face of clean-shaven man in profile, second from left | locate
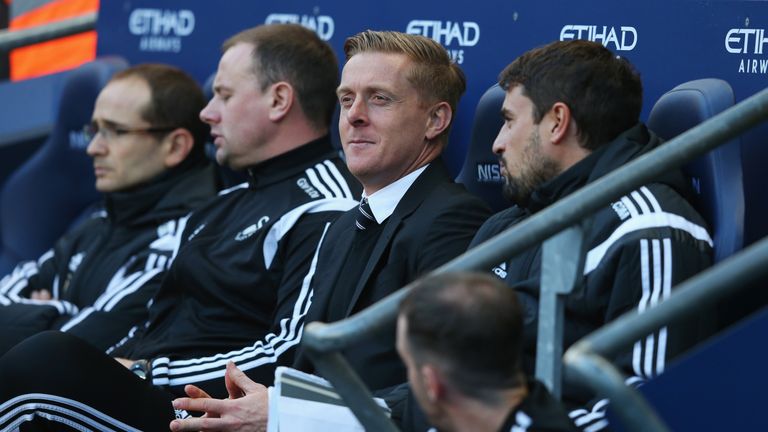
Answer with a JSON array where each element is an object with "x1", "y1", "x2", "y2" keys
[{"x1": 200, "y1": 43, "x2": 272, "y2": 169}]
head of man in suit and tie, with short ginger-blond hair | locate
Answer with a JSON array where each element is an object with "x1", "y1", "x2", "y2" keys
[{"x1": 336, "y1": 31, "x2": 466, "y2": 194}]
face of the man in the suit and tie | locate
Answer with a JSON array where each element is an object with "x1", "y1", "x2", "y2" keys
[{"x1": 337, "y1": 52, "x2": 440, "y2": 194}]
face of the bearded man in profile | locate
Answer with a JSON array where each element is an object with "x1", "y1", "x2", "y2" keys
[{"x1": 493, "y1": 85, "x2": 559, "y2": 205}]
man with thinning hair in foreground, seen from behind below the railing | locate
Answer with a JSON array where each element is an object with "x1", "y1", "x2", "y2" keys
[{"x1": 397, "y1": 273, "x2": 574, "y2": 432}]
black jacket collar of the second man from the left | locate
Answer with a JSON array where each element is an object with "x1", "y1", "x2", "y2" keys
[{"x1": 247, "y1": 135, "x2": 338, "y2": 189}]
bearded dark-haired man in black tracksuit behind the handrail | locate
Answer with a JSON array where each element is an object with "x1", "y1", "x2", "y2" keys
[{"x1": 473, "y1": 40, "x2": 712, "y2": 430}]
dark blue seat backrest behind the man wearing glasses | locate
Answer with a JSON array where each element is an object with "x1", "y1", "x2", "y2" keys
[{"x1": 0, "y1": 57, "x2": 128, "y2": 274}]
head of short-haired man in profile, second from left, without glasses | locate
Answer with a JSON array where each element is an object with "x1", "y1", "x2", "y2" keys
[{"x1": 200, "y1": 24, "x2": 338, "y2": 169}]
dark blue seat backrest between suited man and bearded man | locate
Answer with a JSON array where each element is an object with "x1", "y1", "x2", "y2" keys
[{"x1": 456, "y1": 84, "x2": 509, "y2": 211}]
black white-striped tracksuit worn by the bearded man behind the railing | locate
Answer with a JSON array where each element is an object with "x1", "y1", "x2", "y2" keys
[{"x1": 472, "y1": 124, "x2": 712, "y2": 426}]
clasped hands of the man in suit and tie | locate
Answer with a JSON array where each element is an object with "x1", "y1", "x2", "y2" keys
[{"x1": 170, "y1": 362, "x2": 269, "y2": 432}]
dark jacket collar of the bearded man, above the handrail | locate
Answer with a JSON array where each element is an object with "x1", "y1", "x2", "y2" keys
[{"x1": 525, "y1": 123, "x2": 690, "y2": 213}]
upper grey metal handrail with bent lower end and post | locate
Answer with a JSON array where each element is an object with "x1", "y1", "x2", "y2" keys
[{"x1": 302, "y1": 89, "x2": 768, "y2": 431}]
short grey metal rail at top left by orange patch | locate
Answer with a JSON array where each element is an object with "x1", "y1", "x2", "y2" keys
[{"x1": 0, "y1": 12, "x2": 98, "y2": 52}]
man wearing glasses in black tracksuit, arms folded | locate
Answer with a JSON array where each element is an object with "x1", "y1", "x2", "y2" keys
[{"x1": 0, "y1": 65, "x2": 216, "y2": 354}]
